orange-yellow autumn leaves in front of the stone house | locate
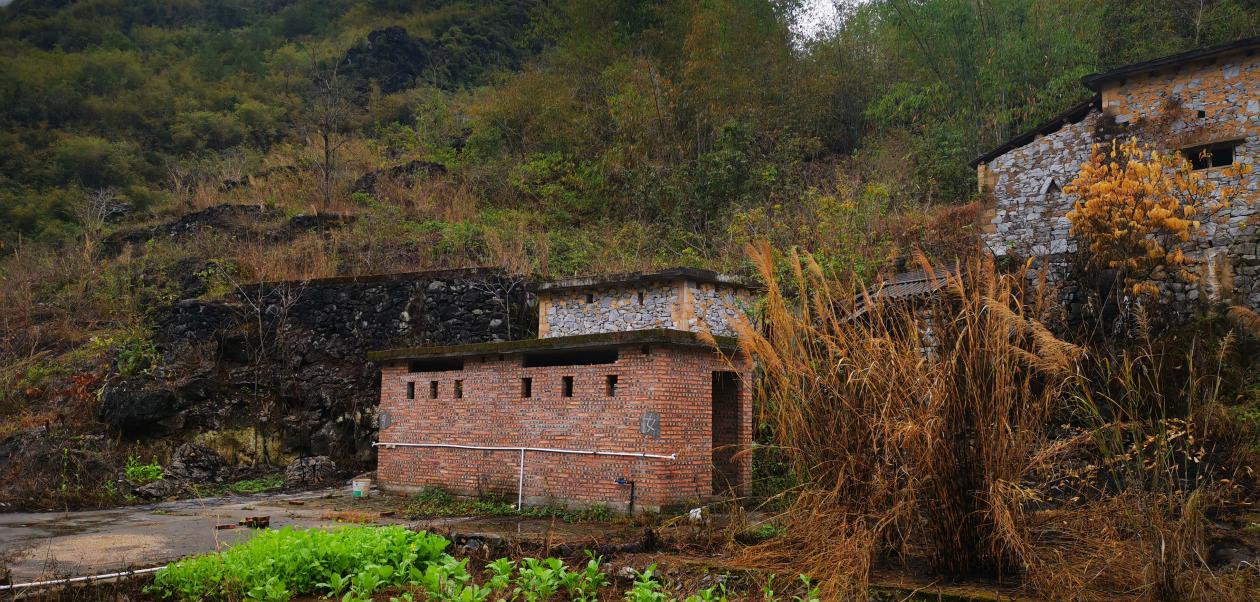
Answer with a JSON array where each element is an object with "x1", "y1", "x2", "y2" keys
[{"x1": 1063, "y1": 139, "x2": 1251, "y2": 298}]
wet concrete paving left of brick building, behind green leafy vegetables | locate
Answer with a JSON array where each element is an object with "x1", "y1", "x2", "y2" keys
[{"x1": 0, "y1": 490, "x2": 367, "y2": 583}]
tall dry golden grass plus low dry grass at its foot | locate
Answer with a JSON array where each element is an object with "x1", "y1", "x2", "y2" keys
[{"x1": 740, "y1": 244, "x2": 1254, "y2": 599}]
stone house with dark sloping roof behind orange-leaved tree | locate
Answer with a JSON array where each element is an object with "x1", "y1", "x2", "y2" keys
[{"x1": 973, "y1": 38, "x2": 1260, "y2": 307}]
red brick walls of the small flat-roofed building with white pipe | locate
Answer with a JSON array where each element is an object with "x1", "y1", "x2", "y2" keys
[{"x1": 377, "y1": 345, "x2": 752, "y2": 509}]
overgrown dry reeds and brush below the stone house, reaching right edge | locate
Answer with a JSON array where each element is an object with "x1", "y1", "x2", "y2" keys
[{"x1": 741, "y1": 241, "x2": 1260, "y2": 599}]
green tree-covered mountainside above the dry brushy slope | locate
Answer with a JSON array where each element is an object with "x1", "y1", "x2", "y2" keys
[{"x1": 0, "y1": 0, "x2": 1260, "y2": 260}]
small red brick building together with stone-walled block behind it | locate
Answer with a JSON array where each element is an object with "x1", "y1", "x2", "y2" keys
[{"x1": 369, "y1": 270, "x2": 752, "y2": 509}]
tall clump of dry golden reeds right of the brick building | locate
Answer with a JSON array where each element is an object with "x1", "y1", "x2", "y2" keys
[{"x1": 740, "y1": 244, "x2": 1081, "y2": 592}]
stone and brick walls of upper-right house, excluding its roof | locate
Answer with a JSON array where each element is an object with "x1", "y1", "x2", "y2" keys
[{"x1": 979, "y1": 48, "x2": 1260, "y2": 310}]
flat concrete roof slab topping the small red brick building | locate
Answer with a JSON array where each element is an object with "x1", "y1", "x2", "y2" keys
[{"x1": 368, "y1": 329, "x2": 738, "y2": 361}]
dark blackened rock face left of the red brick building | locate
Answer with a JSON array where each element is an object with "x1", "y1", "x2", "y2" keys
[{"x1": 97, "y1": 270, "x2": 537, "y2": 467}]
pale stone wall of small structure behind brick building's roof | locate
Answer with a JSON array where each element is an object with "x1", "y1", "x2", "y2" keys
[{"x1": 538, "y1": 278, "x2": 752, "y2": 338}]
